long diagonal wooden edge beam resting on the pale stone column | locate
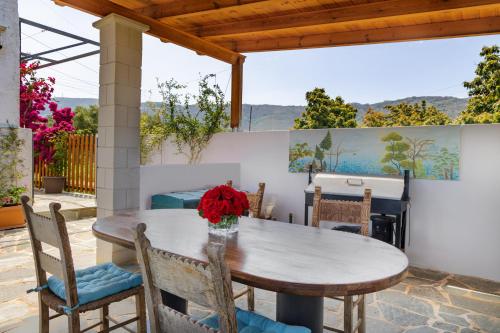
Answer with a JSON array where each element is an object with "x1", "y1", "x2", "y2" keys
[{"x1": 53, "y1": 0, "x2": 244, "y2": 64}]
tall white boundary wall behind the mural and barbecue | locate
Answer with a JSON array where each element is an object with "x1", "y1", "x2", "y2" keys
[{"x1": 155, "y1": 125, "x2": 500, "y2": 281}]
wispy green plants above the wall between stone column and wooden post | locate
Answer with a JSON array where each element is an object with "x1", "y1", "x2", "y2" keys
[{"x1": 141, "y1": 74, "x2": 229, "y2": 163}]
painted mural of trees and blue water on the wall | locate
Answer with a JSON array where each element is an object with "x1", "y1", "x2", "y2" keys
[{"x1": 288, "y1": 126, "x2": 460, "y2": 180}]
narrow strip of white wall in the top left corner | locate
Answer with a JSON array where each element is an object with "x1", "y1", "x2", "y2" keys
[{"x1": 0, "y1": 0, "x2": 19, "y2": 127}]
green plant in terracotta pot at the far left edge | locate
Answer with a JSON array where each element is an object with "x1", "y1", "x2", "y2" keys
[{"x1": 0, "y1": 126, "x2": 26, "y2": 229}]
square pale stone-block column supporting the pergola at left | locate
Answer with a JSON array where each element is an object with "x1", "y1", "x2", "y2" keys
[{"x1": 94, "y1": 14, "x2": 149, "y2": 263}]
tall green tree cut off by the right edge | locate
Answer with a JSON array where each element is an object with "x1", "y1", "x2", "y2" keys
[{"x1": 456, "y1": 45, "x2": 500, "y2": 124}]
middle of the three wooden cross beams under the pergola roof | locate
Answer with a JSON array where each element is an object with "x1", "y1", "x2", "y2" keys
[{"x1": 192, "y1": 0, "x2": 499, "y2": 37}]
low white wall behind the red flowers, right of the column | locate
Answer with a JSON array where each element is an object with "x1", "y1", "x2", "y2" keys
[{"x1": 140, "y1": 163, "x2": 240, "y2": 209}]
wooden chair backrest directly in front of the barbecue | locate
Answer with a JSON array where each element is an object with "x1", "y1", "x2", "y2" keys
[{"x1": 312, "y1": 186, "x2": 372, "y2": 236}]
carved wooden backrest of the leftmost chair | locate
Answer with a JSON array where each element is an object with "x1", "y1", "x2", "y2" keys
[{"x1": 21, "y1": 196, "x2": 78, "y2": 307}]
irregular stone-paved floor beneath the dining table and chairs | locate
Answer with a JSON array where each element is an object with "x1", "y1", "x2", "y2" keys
[{"x1": 0, "y1": 219, "x2": 500, "y2": 333}]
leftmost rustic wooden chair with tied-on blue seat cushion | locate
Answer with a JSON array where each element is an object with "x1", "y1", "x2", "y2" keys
[{"x1": 21, "y1": 196, "x2": 146, "y2": 333}]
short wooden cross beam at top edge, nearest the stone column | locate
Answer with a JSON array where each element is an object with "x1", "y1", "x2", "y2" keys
[{"x1": 136, "y1": 0, "x2": 265, "y2": 19}]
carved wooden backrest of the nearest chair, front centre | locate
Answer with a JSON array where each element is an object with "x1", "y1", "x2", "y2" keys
[{"x1": 135, "y1": 223, "x2": 238, "y2": 333}]
